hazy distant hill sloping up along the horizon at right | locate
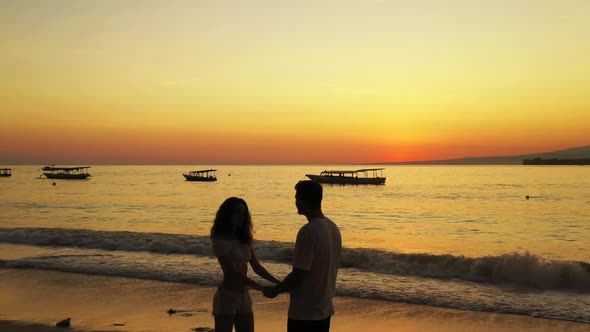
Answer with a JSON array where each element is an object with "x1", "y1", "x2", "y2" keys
[{"x1": 373, "y1": 145, "x2": 590, "y2": 165}]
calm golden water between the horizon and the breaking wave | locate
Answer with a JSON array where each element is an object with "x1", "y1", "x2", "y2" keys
[{"x1": 0, "y1": 166, "x2": 590, "y2": 262}]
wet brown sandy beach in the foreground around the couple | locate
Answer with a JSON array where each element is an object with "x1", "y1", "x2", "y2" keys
[{"x1": 0, "y1": 269, "x2": 590, "y2": 332}]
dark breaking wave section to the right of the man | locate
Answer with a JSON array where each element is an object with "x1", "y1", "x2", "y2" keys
[{"x1": 342, "y1": 248, "x2": 590, "y2": 292}]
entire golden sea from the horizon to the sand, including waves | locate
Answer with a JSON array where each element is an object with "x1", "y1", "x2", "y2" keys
[{"x1": 0, "y1": 165, "x2": 590, "y2": 324}]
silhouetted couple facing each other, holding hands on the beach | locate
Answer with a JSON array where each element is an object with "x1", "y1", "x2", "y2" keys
[{"x1": 211, "y1": 181, "x2": 342, "y2": 332}]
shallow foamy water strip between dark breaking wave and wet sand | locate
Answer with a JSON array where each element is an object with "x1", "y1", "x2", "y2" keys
[{"x1": 0, "y1": 252, "x2": 590, "y2": 323}]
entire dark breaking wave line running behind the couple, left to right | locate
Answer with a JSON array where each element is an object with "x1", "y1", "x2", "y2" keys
[{"x1": 0, "y1": 228, "x2": 590, "y2": 292}]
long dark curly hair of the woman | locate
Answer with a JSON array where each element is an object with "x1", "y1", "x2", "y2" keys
[{"x1": 211, "y1": 197, "x2": 253, "y2": 244}]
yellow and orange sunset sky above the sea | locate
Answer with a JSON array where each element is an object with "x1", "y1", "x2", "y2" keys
[{"x1": 0, "y1": 0, "x2": 590, "y2": 164}]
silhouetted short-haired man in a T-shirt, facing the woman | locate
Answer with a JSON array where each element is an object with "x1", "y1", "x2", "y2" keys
[{"x1": 263, "y1": 181, "x2": 342, "y2": 332}]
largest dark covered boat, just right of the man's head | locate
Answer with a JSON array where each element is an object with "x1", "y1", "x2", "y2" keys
[{"x1": 305, "y1": 168, "x2": 385, "y2": 184}]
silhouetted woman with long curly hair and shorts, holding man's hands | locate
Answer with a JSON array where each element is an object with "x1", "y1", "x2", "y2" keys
[{"x1": 211, "y1": 197, "x2": 279, "y2": 332}]
